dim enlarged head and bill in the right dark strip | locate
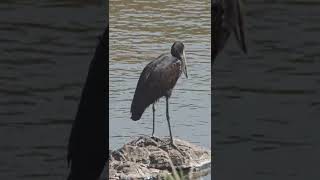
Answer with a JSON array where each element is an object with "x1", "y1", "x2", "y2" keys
[{"x1": 212, "y1": 0, "x2": 247, "y2": 62}]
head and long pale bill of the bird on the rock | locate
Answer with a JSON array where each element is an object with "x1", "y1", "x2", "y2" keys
[{"x1": 171, "y1": 41, "x2": 188, "y2": 78}]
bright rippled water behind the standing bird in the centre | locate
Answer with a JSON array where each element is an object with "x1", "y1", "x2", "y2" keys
[{"x1": 109, "y1": 0, "x2": 211, "y2": 179}]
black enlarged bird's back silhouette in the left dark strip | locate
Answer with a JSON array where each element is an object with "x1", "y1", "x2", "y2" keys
[{"x1": 67, "y1": 27, "x2": 109, "y2": 180}]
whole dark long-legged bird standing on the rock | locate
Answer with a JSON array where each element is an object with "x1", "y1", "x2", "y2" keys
[{"x1": 130, "y1": 41, "x2": 188, "y2": 149}]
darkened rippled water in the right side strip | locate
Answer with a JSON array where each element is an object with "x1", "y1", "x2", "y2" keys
[{"x1": 212, "y1": 0, "x2": 320, "y2": 180}]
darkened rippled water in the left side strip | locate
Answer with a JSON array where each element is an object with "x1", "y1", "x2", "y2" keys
[{"x1": 0, "y1": 0, "x2": 106, "y2": 180}]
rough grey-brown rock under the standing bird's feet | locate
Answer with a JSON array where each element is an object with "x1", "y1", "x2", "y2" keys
[{"x1": 108, "y1": 136, "x2": 211, "y2": 179}]
